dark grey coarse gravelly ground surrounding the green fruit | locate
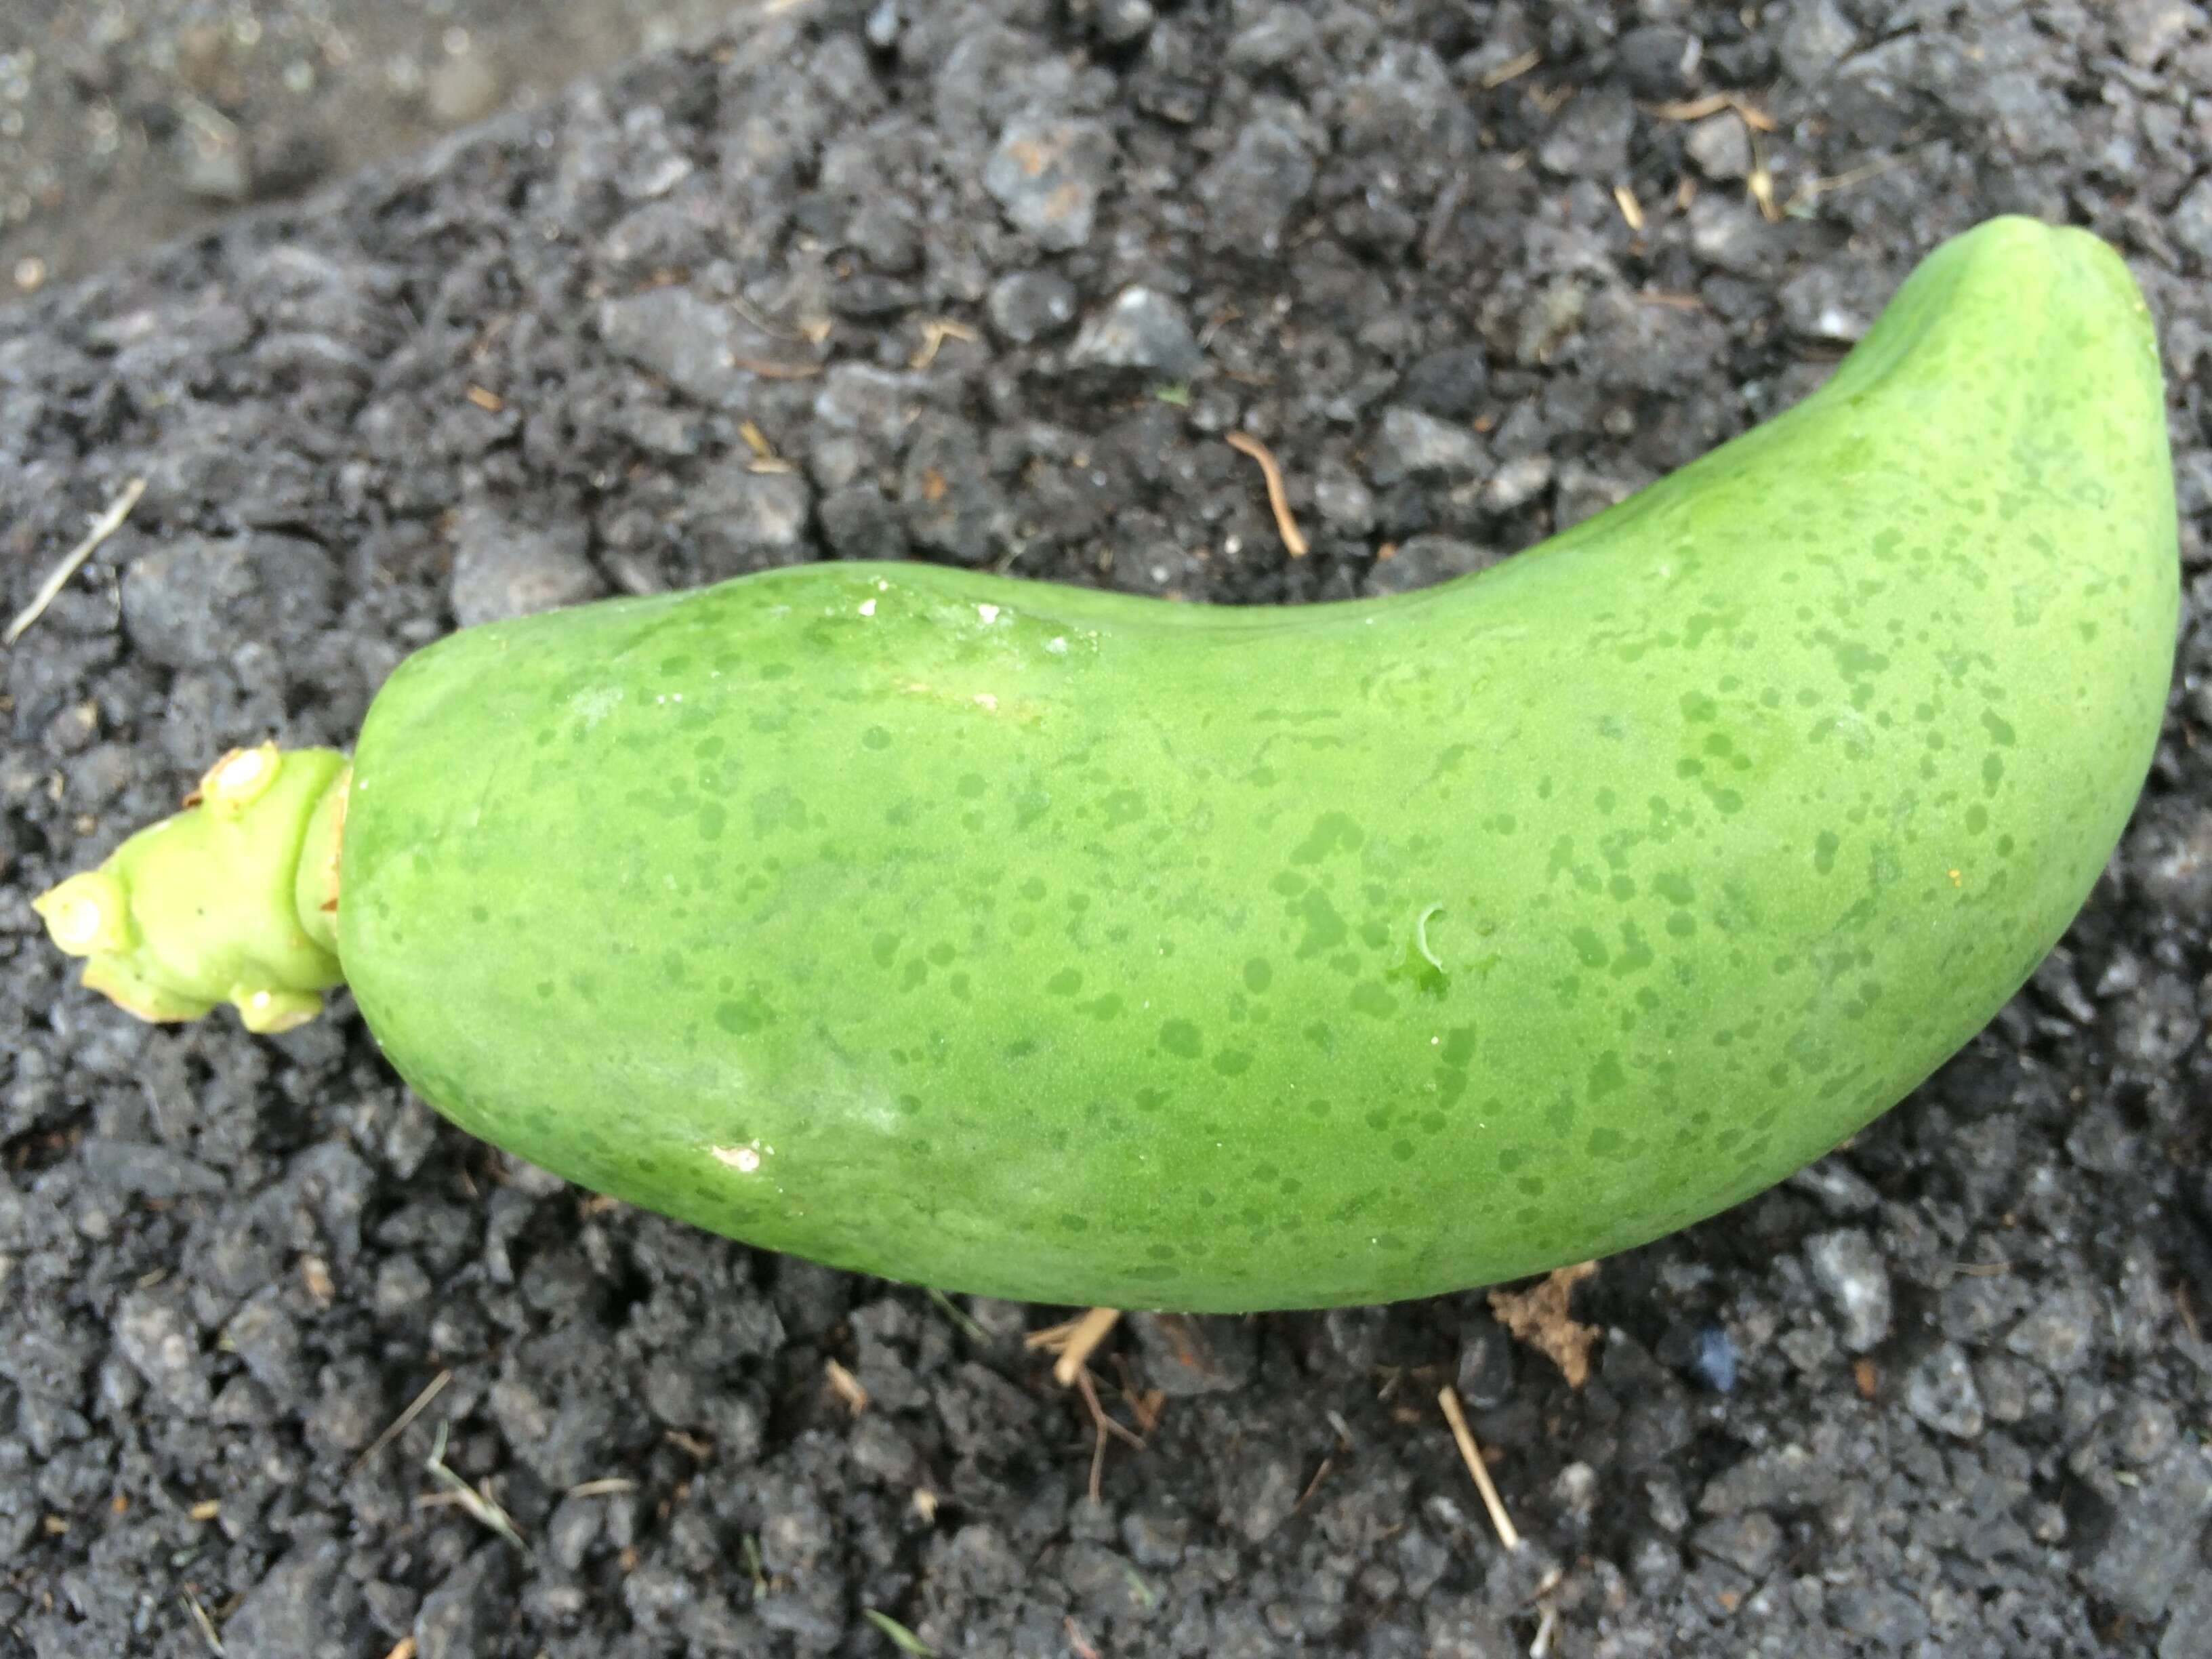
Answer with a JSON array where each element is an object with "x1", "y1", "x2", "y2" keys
[{"x1": 0, "y1": 0, "x2": 2212, "y2": 1659}]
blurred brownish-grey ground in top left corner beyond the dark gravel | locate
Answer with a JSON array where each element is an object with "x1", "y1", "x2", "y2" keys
[{"x1": 0, "y1": 0, "x2": 747, "y2": 294}]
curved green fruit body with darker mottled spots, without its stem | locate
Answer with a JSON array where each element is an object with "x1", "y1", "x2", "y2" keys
[{"x1": 341, "y1": 221, "x2": 2177, "y2": 1309}]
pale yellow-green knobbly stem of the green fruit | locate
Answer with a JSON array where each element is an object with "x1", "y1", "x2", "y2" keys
[{"x1": 31, "y1": 743, "x2": 352, "y2": 1031}]
